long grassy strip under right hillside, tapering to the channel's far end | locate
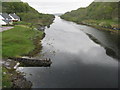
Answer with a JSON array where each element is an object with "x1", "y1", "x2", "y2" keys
[{"x1": 61, "y1": 15, "x2": 120, "y2": 34}]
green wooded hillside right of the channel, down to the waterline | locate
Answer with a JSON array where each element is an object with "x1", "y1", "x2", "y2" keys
[{"x1": 61, "y1": 2, "x2": 120, "y2": 29}]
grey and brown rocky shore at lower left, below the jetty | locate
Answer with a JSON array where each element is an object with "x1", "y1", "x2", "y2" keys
[{"x1": 2, "y1": 59, "x2": 32, "y2": 88}]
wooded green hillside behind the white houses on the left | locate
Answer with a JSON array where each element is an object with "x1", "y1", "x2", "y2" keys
[{"x1": 2, "y1": 2, "x2": 54, "y2": 26}]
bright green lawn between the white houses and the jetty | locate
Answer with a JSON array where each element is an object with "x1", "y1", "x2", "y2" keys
[{"x1": 2, "y1": 26, "x2": 43, "y2": 58}]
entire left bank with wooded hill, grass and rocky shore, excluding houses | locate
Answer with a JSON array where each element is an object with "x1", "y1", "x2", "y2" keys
[{"x1": 0, "y1": 2, "x2": 54, "y2": 89}]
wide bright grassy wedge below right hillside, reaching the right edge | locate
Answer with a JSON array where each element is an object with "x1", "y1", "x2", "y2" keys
[{"x1": 78, "y1": 20, "x2": 120, "y2": 34}]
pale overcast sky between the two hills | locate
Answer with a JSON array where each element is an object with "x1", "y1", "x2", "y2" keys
[{"x1": 22, "y1": 0, "x2": 94, "y2": 14}]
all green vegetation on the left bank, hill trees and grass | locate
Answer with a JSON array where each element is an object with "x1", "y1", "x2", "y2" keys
[{"x1": 0, "y1": 2, "x2": 54, "y2": 88}]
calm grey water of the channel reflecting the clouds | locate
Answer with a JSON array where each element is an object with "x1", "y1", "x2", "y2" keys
[{"x1": 19, "y1": 16, "x2": 118, "y2": 88}]
